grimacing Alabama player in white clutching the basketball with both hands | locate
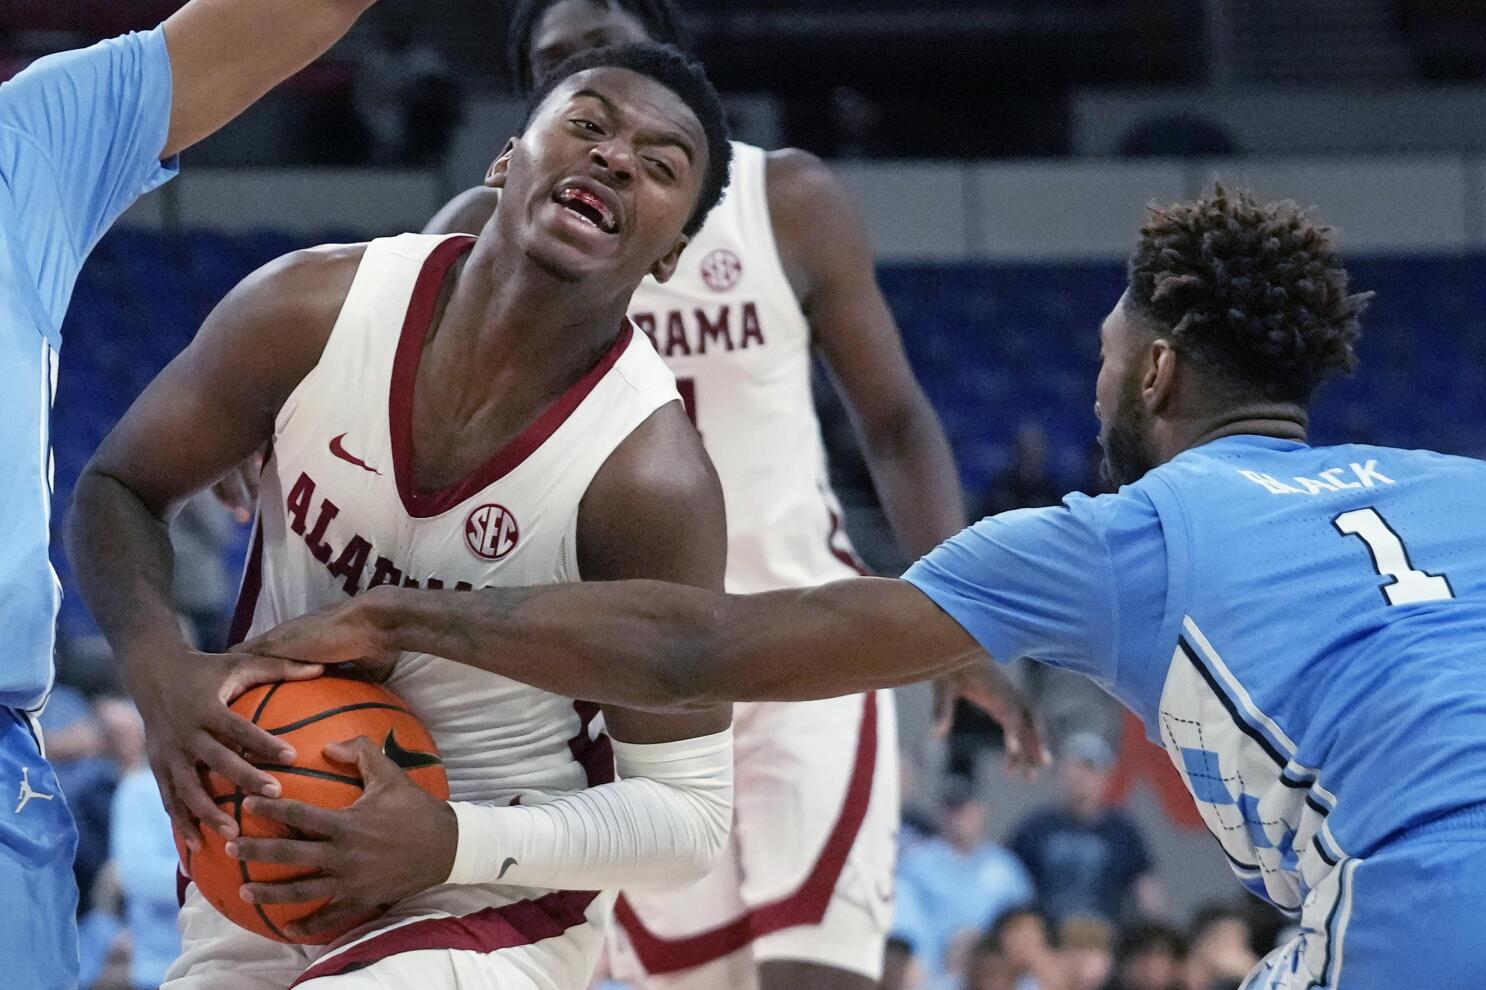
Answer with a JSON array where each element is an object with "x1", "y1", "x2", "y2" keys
[{"x1": 71, "y1": 45, "x2": 733, "y2": 990}]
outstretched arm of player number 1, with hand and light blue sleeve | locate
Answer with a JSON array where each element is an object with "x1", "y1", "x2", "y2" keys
[{"x1": 248, "y1": 492, "x2": 1147, "y2": 728}]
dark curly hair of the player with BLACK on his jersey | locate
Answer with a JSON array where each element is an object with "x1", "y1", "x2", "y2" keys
[{"x1": 1129, "y1": 184, "x2": 1373, "y2": 404}]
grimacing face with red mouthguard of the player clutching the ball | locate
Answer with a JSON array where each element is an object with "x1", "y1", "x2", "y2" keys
[{"x1": 490, "y1": 67, "x2": 707, "y2": 291}]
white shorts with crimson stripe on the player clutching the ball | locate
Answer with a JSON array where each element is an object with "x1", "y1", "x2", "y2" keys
[{"x1": 162, "y1": 884, "x2": 612, "y2": 990}]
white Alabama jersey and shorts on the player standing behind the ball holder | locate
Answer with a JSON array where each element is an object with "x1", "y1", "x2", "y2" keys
[{"x1": 614, "y1": 143, "x2": 898, "y2": 990}]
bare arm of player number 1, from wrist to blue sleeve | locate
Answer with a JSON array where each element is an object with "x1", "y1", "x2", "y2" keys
[{"x1": 350, "y1": 578, "x2": 979, "y2": 712}]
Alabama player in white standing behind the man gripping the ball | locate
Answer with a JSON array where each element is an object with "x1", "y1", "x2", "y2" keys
[{"x1": 428, "y1": 0, "x2": 1022, "y2": 990}]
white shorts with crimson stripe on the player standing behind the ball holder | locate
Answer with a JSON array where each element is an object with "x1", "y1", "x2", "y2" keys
[{"x1": 611, "y1": 691, "x2": 898, "y2": 990}]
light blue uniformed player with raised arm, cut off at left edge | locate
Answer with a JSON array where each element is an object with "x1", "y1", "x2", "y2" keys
[{"x1": 0, "y1": 0, "x2": 374, "y2": 990}]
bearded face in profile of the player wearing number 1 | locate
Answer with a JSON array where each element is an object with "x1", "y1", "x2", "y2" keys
[{"x1": 1094, "y1": 296, "x2": 1156, "y2": 486}]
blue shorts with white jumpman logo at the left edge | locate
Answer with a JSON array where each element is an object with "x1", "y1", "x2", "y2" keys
[{"x1": 0, "y1": 708, "x2": 77, "y2": 990}]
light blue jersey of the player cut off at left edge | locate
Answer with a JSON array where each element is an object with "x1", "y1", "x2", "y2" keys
[{"x1": 0, "y1": 28, "x2": 174, "y2": 709}]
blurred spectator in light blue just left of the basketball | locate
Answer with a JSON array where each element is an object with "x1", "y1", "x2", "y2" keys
[{"x1": 98, "y1": 699, "x2": 180, "y2": 990}]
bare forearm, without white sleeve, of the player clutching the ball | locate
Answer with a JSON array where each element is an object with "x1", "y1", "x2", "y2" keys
[{"x1": 67, "y1": 471, "x2": 189, "y2": 690}]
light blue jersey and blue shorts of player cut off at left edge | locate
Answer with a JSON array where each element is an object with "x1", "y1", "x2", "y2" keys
[{"x1": 0, "y1": 30, "x2": 174, "y2": 990}]
